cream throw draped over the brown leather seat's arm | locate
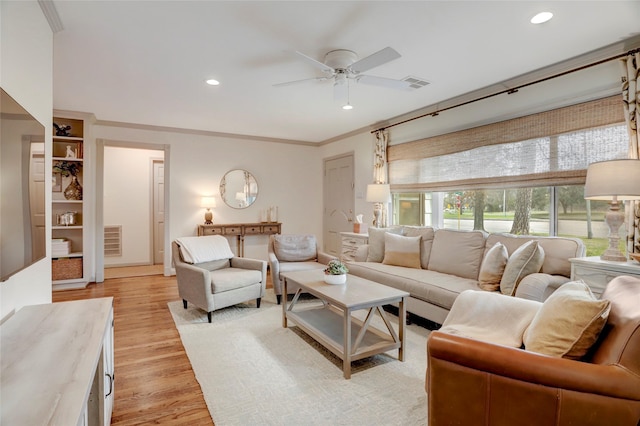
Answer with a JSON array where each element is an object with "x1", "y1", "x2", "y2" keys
[{"x1": 440, "y1": 290, "x2": 542, "y2": 348}]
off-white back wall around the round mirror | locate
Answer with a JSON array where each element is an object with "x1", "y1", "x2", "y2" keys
[{"x1": 94, "y1": 123, "x2": 322, "y2": 260}]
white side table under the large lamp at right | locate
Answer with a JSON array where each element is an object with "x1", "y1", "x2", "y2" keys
[{"x1": 569, "y1": 256, "x2": 640, "y2": 297}]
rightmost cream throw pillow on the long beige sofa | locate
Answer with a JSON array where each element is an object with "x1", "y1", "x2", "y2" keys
[{"x1": 500, "y1": 240, "x2": 544, "y2": 296}]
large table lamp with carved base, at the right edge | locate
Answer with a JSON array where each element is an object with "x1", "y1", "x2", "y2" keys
[{"x1": 584, "y1": 160, "x2": 640, "y2": 262}]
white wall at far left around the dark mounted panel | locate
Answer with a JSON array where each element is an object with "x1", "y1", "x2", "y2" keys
[{"x1": 0, "y1": 1, "x2": 53, "y2": 321}]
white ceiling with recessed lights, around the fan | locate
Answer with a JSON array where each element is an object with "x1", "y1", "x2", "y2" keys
[{"x1": 53, "y1": 0, "x2": 640, "y2": 143}]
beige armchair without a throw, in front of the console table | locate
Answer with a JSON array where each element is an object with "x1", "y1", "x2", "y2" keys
[{"x1": 268, "y1": 234, "x2": 335, "y2": 304}]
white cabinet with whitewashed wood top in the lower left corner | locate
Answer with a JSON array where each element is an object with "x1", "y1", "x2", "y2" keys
[{"x1": 0, "y1": 297, "x2": 114, "y2": 426}]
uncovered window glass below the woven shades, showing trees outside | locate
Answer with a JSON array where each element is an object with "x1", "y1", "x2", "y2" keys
[{"x1": 393, "y1": 185, "x2": 624, "y2": 256}]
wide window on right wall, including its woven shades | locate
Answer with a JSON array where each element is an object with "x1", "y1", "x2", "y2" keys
[{"x1": 387, "y1": 96, "x2": 629, "y2": 255}]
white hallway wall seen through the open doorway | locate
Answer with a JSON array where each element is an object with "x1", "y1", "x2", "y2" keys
[{"x1": 103, "y1": 146, "x2": 163, "y2": 266}]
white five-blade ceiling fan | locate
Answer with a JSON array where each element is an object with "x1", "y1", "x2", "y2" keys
[{"x1": 274, "y1": 47, "x2": 416, "y2": 103}]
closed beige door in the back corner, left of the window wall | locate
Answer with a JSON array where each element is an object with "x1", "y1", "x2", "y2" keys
[{"x1": 324, "y1": 154, "x2": 355, "y2": 256}]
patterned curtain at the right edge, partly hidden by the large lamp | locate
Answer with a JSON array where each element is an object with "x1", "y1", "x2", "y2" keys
[{"x1": 621, "y1": 52, "x2": 640, "y2": 253}]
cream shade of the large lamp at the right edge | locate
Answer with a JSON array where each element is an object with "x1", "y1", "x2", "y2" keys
[{"x1": 584, "y1": 160, "x2": 640, "y2": 201}]
